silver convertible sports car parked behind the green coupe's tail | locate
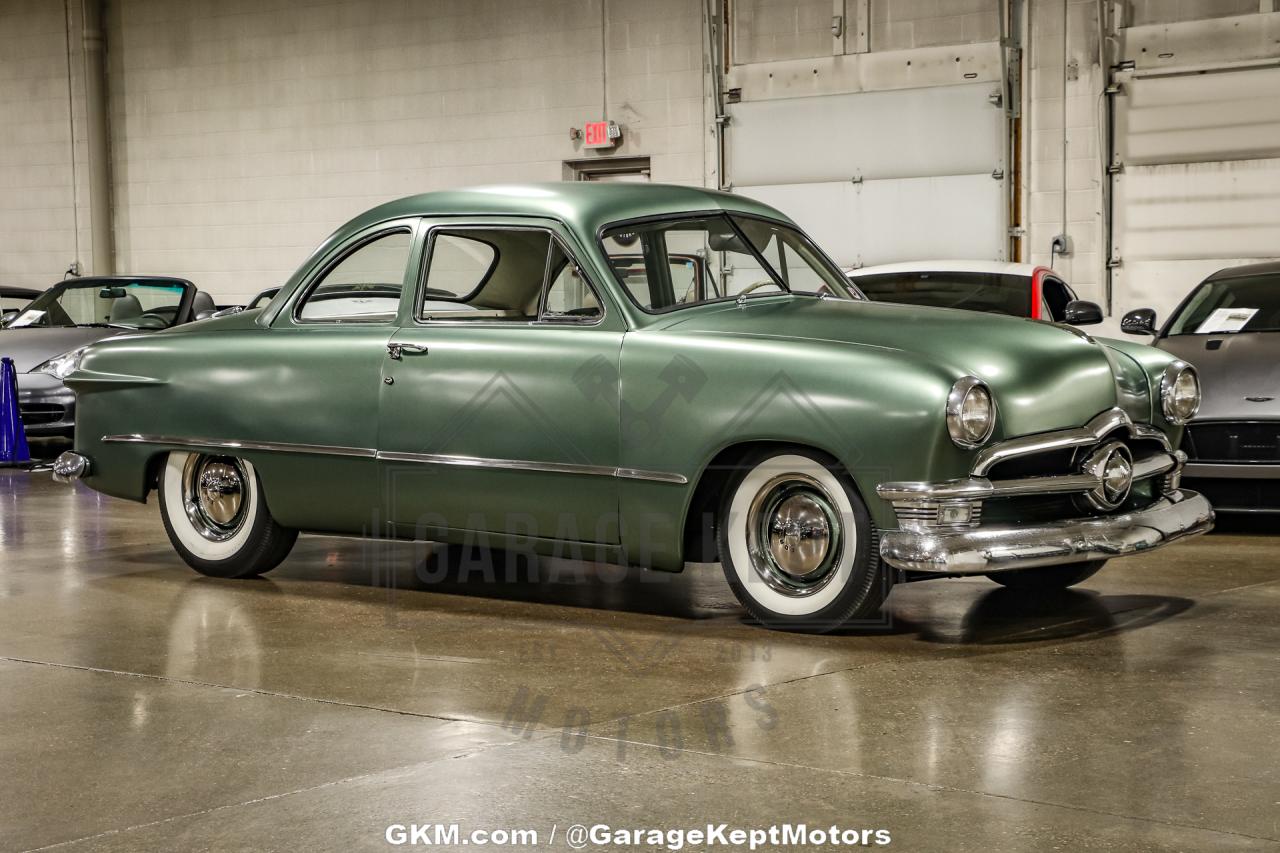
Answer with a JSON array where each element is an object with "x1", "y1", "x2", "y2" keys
[{"x1": 0, "y1": 275, "x2": 214, "y2": 435}]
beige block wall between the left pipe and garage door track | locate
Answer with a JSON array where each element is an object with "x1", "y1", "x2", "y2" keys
[{"x1": 108, "y1": 0, "x2": 703, "y2": 301}]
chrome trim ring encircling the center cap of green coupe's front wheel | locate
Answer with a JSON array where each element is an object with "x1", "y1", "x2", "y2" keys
[{"x1": 746, "y1": 471, "x2": 844, "y2": 598}]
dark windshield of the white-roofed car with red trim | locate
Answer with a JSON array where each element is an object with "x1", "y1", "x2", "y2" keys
[{"x1": 854, "y1": 272, "x2": 1032, "y2": 316}]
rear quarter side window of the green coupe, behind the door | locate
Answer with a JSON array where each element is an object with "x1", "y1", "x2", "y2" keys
[{"x1": 296, "y1": 228, "x2": 413, "y2": 323}]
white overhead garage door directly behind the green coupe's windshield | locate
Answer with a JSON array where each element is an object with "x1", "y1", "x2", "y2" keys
[{"x1": 726, "y1": 82, "x2": 1007, "y2": 266}]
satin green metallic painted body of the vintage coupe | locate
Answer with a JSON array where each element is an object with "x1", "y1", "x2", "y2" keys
[{"x1": 60, "y1": 184, "x2": 1179, "y2": 570}]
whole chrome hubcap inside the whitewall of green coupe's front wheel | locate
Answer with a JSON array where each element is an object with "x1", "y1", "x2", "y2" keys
[{"x1": 746, "y1": 474, "x2": 841, "y2": 597}]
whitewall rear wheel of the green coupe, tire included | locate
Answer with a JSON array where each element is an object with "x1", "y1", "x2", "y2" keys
[{"x1": 160, "y1": 452, "x2": 298, "y2": 578}]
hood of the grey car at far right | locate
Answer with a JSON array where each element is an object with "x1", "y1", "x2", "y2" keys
[{"x1": 1157, "y1": 332, "x2": 1280, "y2": 420}]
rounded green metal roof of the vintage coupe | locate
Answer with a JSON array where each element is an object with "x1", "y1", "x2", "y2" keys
[{"x1": 338, "y1": 181, "x2": 791, "y2": 234}]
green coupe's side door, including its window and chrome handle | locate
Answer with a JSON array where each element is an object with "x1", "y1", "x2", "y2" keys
[{"x1": 379, "y1": 219, "x2": 625, "y2": 546}]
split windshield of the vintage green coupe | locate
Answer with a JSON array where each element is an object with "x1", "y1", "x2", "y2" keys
[{"x1": 602, "y1": 214, "x2": 851, "y2": 313}]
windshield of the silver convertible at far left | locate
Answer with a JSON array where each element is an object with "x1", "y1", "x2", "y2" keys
[{"x1": 8, "y1": 279, "x2": 187, "y2": 329}]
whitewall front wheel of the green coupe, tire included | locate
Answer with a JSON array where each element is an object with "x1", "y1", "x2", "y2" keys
[{"x1": 719, "y1": 448, "x2": 892, "y2": 631}]
